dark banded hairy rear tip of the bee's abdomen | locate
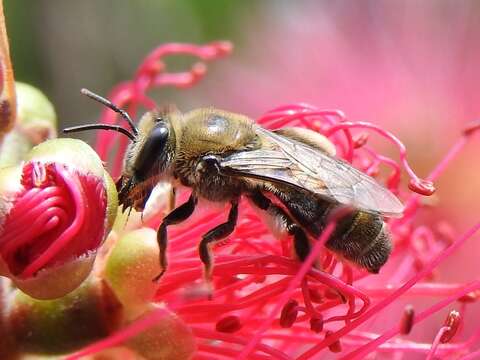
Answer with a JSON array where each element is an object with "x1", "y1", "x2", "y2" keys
[{"x1": 326, "y1": 211, "x2": 392, "y2": 273}]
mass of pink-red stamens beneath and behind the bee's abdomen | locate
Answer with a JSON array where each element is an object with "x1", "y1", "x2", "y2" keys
[{"x1": 110, "y1": 104, "x2": 480, "y2": 359}]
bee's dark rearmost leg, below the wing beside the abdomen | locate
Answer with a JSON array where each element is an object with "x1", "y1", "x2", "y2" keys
[{"x1": 249, "y1": 191, "x2": 311, "y2": 261}]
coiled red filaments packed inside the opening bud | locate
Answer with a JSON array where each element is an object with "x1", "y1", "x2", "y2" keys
[{"x1": 0, "y1": 161, "x2": 106, "y2": 278}]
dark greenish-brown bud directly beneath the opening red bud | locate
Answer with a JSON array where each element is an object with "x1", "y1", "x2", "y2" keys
[{"x1": 4, "y1": 277, "x2": 122, "y2": 355}]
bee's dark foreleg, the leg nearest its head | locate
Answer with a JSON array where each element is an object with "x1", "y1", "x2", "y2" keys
[{"x1": 153, "y1": 194, "x2": 197, "y2": 281}]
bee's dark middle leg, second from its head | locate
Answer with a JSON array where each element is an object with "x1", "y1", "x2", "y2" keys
[{"x1": 198, "y1": 200, "x2": 238, "y2": 283}]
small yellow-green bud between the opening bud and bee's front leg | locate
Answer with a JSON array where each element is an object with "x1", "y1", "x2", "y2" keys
[{"x1": 105, "y1": 228, "x2": 160, "y2": 311}]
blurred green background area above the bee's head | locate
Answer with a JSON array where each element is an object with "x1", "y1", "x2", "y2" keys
[{"x1": 4, "y1": 0, "x2": 259, "y2": 129}]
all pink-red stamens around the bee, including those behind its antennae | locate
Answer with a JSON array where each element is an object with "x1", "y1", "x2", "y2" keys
[{"x1": 77, "y1": 40, "x2": 479, "y2": 359}]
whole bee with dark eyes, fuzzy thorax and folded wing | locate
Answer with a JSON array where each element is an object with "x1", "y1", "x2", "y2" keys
[{"x1": 64, "y1": 89, "x2": 403, "y2": 280}]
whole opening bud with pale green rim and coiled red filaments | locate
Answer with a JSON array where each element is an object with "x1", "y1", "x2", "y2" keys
[{"x1": 0, "y1": 139, "x2": 117, "y2": 299}]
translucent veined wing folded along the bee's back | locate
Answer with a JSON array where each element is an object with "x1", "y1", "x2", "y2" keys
[{"x1": 220, "y1": 127, "x2": 403, "y2": 216}]
